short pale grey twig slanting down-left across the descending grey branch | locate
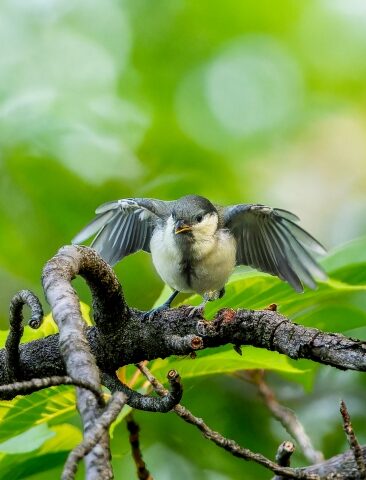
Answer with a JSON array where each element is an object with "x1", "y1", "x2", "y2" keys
[{"x1": 61, "y1": 392, "x2": 126, "y2": 480}]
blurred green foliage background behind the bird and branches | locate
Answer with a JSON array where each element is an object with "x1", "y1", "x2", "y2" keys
[{"x1": 0, "y1": 0, "x2": 366, "y2": 480}]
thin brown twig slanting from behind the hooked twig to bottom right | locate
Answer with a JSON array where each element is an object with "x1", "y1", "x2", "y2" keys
[{"x1": 137, "y1": 364, "x2": 317, "y2": 479}]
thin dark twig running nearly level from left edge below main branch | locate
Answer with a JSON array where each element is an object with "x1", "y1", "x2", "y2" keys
[{"x1": 0, "y1": 376, "x2": 105, "y2": 407}]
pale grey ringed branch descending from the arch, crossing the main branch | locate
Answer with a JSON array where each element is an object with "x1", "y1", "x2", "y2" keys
[{"x1": 42, "y1": 247, "x2": 113, "y2": 480}]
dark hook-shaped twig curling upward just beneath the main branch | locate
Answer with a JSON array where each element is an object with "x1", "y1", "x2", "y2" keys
[{"x1": 102, "y1": 370, "x2": 183, "y2": 413}]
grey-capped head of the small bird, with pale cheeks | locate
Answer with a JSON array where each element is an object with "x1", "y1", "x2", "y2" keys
[{"x1": 172, "y1": 195, "x2": 218, "y2": 240}]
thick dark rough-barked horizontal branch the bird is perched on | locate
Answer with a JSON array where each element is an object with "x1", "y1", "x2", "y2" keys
[{"x1": 0, "y1": 299, "x2": 366, "y2": 385}]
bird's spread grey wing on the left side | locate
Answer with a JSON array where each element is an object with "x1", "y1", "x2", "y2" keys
[{"x1": 72, "y1": 198, "x2": 172, "y2": 265}]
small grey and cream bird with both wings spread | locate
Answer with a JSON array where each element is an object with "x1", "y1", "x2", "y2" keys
[{"x1": 72, "y1": 195, "x2": 327, "y2": 319}]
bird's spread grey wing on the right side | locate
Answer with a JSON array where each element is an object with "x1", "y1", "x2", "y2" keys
[{"x1": 223, "y1": 204, "x2": 326, "y2": 292}]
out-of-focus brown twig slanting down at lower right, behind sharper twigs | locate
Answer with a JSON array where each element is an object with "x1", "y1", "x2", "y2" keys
[{"x1": 243, "y1": 370, "x2": 324, "y2": 463}]
